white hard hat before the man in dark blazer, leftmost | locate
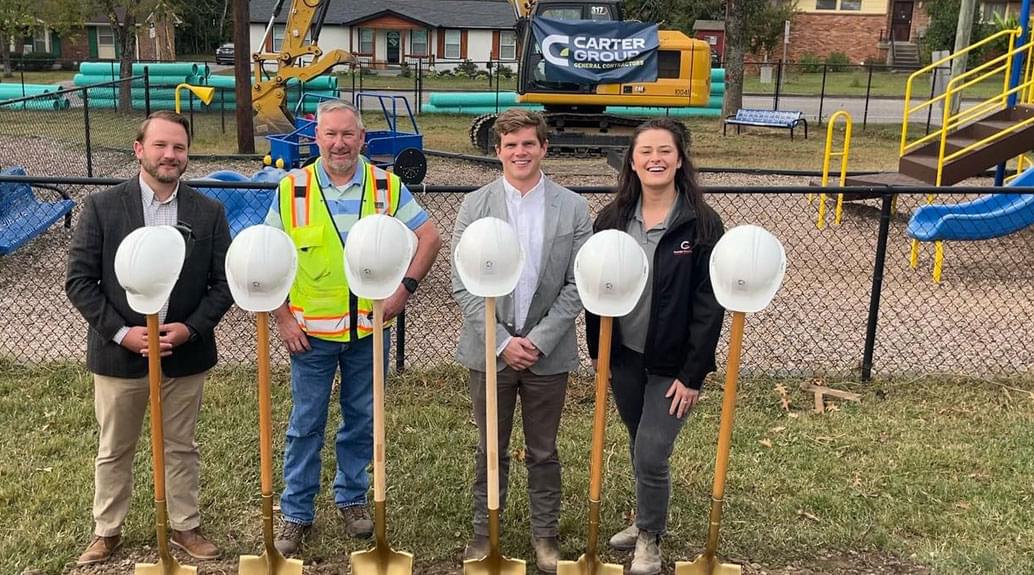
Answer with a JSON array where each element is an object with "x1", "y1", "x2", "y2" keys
[{"x1": 115, "y1": 225, "x2": 186, "y2": 315}]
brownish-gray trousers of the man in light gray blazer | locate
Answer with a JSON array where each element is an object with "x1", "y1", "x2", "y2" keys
[{"x1": 470, "y1": 366, "x2": 568, "y2": 537}]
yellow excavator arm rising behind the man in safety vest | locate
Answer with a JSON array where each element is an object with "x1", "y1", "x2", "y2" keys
[{"x1": 251, "y1": 0, "x2": 356, "y2": 133}]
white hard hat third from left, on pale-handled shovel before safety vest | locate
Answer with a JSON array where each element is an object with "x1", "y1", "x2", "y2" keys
[{"x1": 344, "y1": 214, "x2": 417, "y2": 300}]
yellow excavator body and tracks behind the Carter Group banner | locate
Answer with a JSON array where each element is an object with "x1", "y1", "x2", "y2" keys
[{"x1": 470, "y1": 0, "x2": 710, "y2": 156}]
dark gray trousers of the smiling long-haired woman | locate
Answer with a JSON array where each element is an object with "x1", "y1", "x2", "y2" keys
[{"x1": 610, "y1": 345, "x2": 689, "y2": 535}]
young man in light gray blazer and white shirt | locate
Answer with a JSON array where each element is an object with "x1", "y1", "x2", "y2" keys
[{"x1": 452, "y1": 109, "x2": 592, "y2": 573}]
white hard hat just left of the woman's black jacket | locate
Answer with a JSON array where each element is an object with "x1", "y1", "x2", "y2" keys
[{"x1": 575, "y1": 230, "x2": 649, "y2": 317}]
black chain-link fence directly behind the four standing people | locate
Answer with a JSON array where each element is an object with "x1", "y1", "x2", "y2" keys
[{"x1": 0, "y1": 176, "x2": 1034, "y2": 377}]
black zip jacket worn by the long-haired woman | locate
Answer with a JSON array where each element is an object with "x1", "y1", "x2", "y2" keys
[{"x1": 585, "y1": 201, "x2": 725, "y2": 390}]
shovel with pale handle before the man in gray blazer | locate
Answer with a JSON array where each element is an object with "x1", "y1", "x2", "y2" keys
[{"x1": 463, "y1": 297, "x2": 525, "y2": 575}]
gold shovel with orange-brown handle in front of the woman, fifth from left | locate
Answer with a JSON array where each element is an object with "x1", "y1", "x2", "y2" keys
[{"x1": 556, "y1": 315, "x2": 624, "y2": 575}]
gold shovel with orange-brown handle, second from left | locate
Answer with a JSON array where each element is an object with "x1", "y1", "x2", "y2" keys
[{"x1": 239, "y1": 311, "x2": 302, "y2": 575}]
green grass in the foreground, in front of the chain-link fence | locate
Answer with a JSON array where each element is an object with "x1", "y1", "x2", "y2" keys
[{"x1": 0, "y1": 363, "x2": 1034, "y2": 575}]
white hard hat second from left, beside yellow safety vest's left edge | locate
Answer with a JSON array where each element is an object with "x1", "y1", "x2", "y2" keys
[{"x1": 226, "y1": 225, "x2": 298, "y2": 311}]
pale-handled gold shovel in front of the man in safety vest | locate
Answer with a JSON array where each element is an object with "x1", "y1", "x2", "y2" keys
[{"x1": 351, "y1": 300, "x2": 413, "y2": 575}]
